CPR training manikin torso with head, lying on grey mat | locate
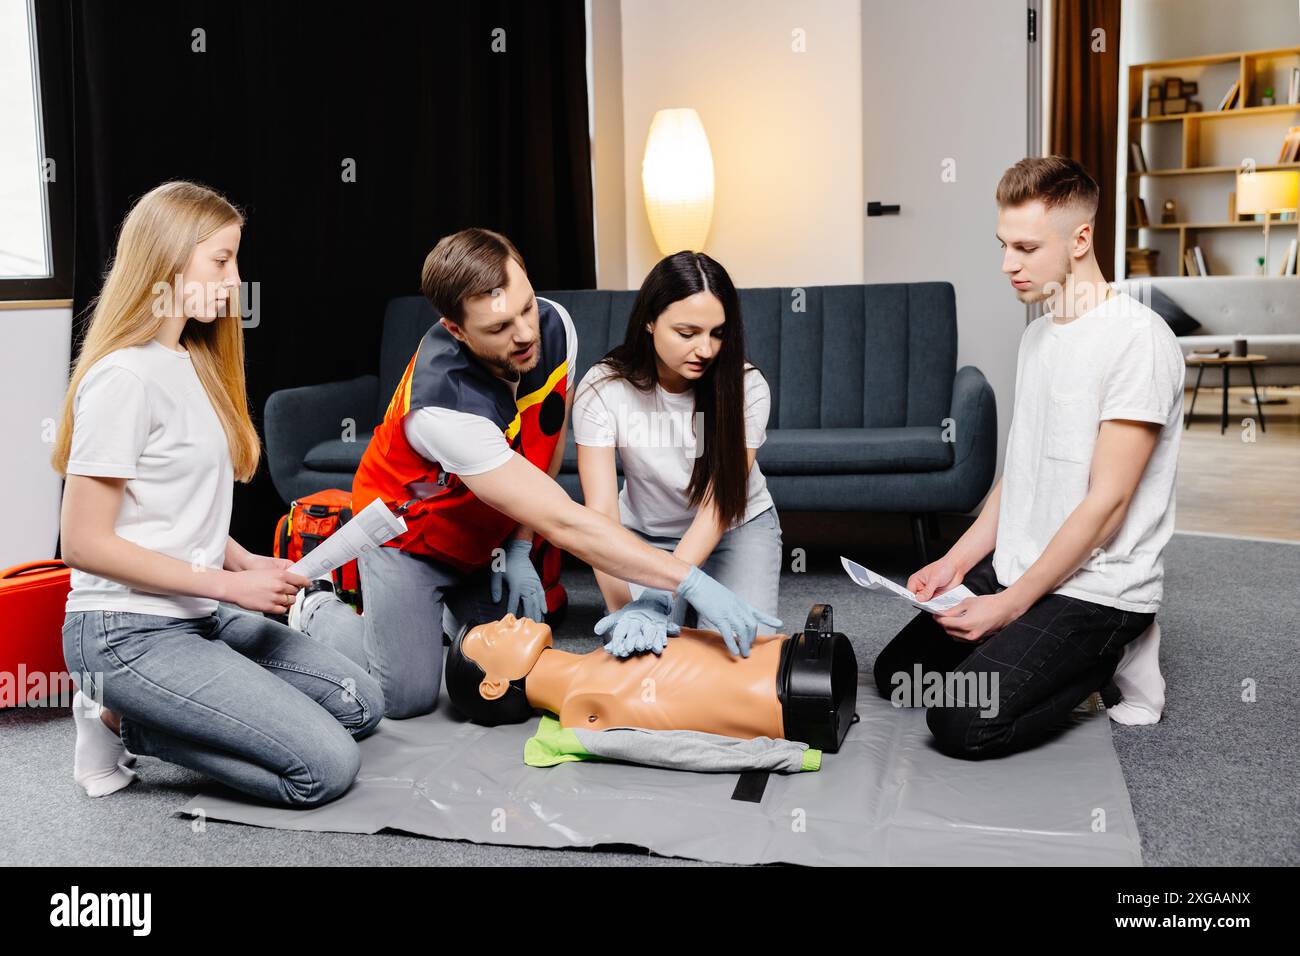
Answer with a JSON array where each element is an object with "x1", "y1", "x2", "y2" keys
[{"x1": 446, "y1": 605, "x2": 858, "y2": 753}]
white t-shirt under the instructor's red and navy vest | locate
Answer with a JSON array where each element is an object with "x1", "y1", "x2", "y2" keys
[{"x1": 402, "y1": 298, "x2": 577, "y2": 478}]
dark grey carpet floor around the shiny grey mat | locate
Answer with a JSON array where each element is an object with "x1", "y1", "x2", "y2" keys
[{"x1": 0, "y1": 515, "x2": 1300, "y2": 866}]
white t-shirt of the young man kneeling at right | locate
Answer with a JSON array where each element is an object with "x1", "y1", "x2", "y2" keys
[{"x1": 993, "y1": 293, "x2": 1184, "y2": 613}]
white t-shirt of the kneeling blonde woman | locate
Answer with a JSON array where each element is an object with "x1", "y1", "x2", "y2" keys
[{"x1": 66, "y1": 339, "x2": 234, "y2": 618}]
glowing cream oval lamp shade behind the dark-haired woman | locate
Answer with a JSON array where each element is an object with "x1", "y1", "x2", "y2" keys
[{"x1": 641, "y1": 109, "x2": 714, "y2": 255}]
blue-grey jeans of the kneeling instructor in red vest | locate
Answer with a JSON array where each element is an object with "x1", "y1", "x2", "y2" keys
[{"x1": 299, "y1": 548, "x2": 507, "y2": 719}]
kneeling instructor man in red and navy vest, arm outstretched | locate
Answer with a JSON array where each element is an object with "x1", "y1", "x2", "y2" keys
[{"x1": 290, "y1": 229, "x2": 781, "y2": 718}]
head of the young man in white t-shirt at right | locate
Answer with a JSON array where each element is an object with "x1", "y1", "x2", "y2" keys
[{"x1": 997, "y1": 156, "x2": 1101, "y2": 306}]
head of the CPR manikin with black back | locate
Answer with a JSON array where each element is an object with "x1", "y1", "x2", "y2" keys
[{"x1": 446, "y1": 614, "x2": 553, "y2": 726}]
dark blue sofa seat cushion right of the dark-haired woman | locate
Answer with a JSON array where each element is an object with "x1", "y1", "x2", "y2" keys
[{"x1": 758, "y1": 425, "x2": 953, "y2": 475}]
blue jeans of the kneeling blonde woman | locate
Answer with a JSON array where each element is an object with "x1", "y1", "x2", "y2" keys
[{"x1": 64, "y1": 605, "x2": 384, "y2": 806}]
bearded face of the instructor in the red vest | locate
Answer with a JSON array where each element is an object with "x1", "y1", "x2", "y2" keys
[{"x1": 442, "y1": 259, "x2": 542, "y2": 380}]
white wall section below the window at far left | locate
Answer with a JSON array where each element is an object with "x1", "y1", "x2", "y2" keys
[{"x1": 0, "y1": 303, "x2": 72, "y2": 570}]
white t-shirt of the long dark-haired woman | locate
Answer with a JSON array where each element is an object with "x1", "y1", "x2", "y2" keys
[{"x1": 573, "y1": 363, "x2": 772, "y2": 537}]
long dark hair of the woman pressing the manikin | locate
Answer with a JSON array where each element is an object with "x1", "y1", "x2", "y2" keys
[{"x1": 602, "y1": 252, "x2": 749, "y2": 527}]
